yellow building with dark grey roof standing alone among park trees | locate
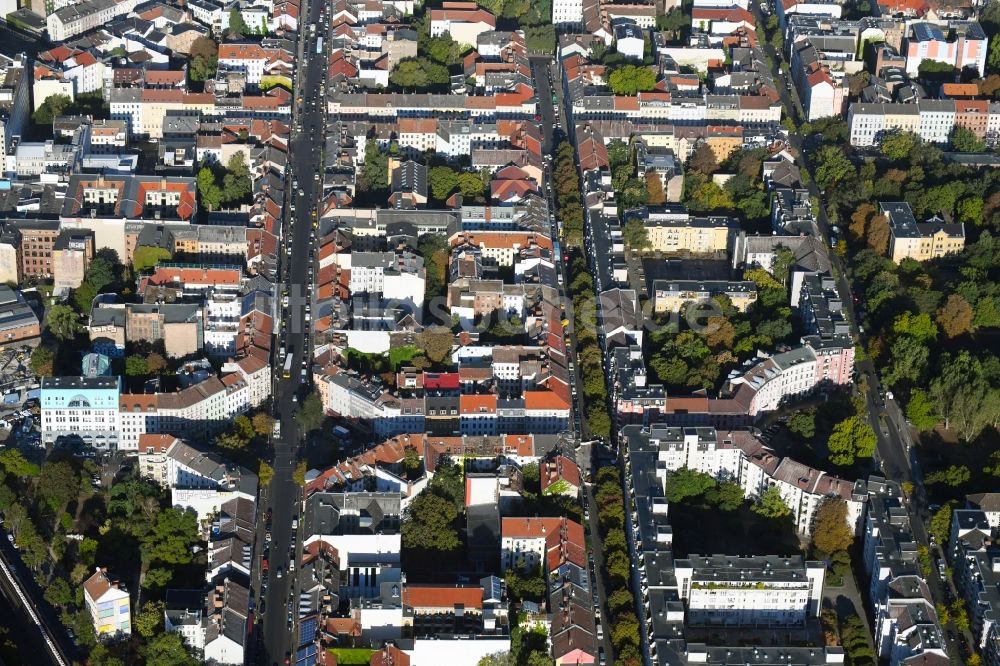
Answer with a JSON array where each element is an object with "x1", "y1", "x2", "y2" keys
[{"x1": 879, "y1": 201, "x2": 965, "y2": 264}]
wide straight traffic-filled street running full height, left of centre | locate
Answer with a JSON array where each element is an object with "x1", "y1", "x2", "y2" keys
[{"x1": 256, "y1": 0, "x2": 326, "y2": 664}]
